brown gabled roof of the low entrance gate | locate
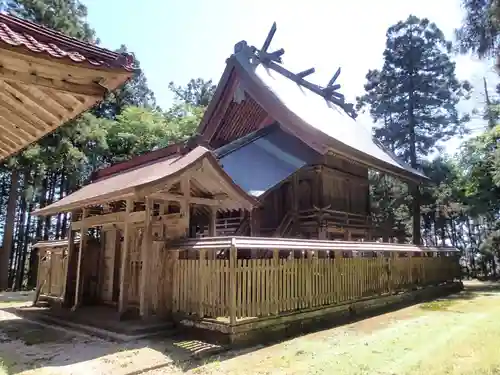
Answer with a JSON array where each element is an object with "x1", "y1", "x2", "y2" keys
[{"x1": 34, "y1": 146, "x2": 258, "y2": 215}]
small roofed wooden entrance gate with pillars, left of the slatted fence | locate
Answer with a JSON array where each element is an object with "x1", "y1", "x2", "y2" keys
[{"x1": 35, "y1": 146, "x2": 257, "y2": 316}]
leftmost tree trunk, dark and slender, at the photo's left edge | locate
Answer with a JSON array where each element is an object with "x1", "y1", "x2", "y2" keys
[{"x1": 0, "y1": 169, "x2": 19, "y2": 290}]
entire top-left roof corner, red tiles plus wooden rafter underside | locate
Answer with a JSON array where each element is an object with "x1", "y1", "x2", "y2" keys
[{"x1": 0, "y1": 13, "x2": 134, "y2": 162}]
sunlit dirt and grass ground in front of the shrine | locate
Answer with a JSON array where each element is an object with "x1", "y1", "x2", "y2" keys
[{"x1": 0, "y1": 282, "x2": 500, "y2": 375}]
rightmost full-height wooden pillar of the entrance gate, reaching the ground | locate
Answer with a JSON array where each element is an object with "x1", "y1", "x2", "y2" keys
[{"x1": 139, "y1": 197, "x2": 153, "y2": 318}]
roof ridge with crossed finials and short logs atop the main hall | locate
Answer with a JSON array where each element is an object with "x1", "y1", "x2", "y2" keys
[{"x1": 234, "y1": 22, "x2": 357, "y2": 118}]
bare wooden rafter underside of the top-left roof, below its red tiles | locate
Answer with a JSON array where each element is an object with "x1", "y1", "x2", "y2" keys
[{"x1": 0, "y1": 34, "x2": 133, "y2": 161}]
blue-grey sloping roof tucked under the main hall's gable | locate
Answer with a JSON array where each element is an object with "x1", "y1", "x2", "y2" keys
[{"x1": 215, "y1": 124, "x2": 319, "y2": 197}]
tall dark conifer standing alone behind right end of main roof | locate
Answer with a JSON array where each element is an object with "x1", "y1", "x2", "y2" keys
[{"x1": 358, "y1": 16, "x2": 471, "y2": 244}]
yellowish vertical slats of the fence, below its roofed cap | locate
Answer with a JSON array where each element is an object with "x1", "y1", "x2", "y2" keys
[{"x1": 173, "y1": 257, "x2": 460, "y2": 319}]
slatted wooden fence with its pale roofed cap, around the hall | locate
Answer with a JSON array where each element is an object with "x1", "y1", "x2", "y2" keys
[{"x1": 172, "y1": 237, "x2": 460, "y2": 324}]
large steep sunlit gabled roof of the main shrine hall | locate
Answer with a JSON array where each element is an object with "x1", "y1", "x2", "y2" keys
[{"x1": 198, "y1": 42, "x2": 427, "y2": 181}]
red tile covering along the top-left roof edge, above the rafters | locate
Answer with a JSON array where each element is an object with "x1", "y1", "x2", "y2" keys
[{"x1": 0, "y1": 12, "x2": 134, "y2": 71}]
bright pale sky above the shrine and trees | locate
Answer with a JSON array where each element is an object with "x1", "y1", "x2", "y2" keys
[{"x1": 82, "y1": 0, "x2": 498, "y2": 156}]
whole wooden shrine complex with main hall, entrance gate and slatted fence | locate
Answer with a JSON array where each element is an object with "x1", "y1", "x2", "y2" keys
[{"x1": 31, "y1": 27, "x2": 459, "y2": 340}]
